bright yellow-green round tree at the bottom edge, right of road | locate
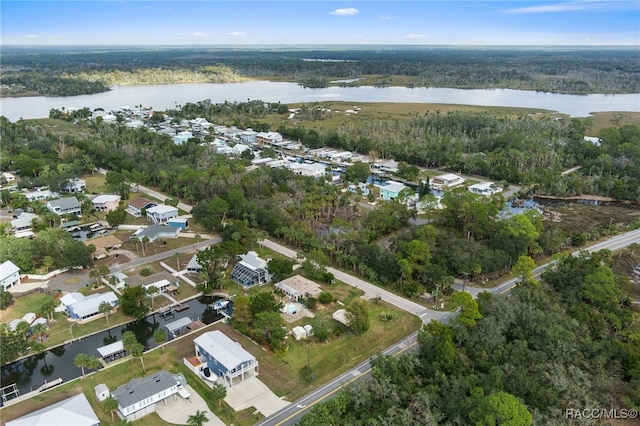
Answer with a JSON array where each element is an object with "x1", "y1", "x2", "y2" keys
[{"x1": 469, "y1": 392, "x2": 533, "y2": 426}]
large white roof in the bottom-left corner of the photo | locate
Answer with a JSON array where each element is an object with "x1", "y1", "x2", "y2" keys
[{"x1": 5, "y1": 393, "x2": 100, "y2": 426}]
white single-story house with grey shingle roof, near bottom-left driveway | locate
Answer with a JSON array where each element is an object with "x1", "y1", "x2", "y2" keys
[{"x1": 111, "y1": 370, "x2": 178, "y2": 421}]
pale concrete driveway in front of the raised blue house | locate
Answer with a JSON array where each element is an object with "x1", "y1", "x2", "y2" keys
[{"x1": 224, "y1": 377, "x2": 291, "y2": 417}]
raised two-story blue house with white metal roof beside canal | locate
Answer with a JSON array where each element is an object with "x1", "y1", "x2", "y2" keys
[{"x1": 193, "y1": 330, "x2": 258, "y2": 386}]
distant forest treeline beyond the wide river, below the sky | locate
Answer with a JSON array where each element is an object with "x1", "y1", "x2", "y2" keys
[{"x1": 2, "y1": 47, "x2": 640, "y2": 95}]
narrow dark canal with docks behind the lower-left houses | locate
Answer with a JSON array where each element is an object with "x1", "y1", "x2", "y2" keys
[{"x1": 0, "y1": 296, "x2": 222, "y2": 404}]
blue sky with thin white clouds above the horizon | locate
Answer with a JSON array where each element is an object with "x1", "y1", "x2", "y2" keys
[{"x1": 0, "y1": 0, "x2": 640, "y2": 46}]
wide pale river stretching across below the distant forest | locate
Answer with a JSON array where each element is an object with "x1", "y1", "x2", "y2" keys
[{"x1": 0, "y1": 81, "x2": 640, "y2": 122}]
